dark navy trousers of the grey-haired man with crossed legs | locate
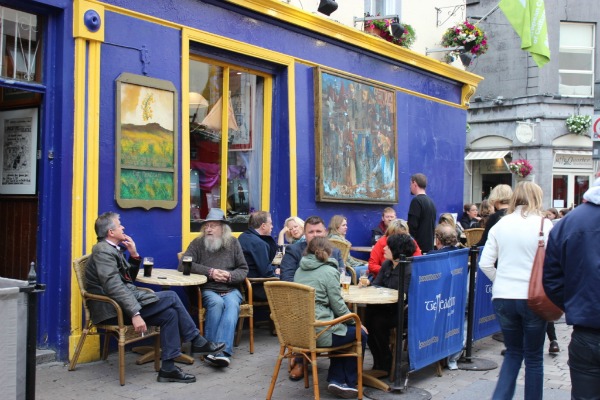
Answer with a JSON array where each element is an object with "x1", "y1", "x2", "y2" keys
[{"x1": 140, "y1": 290, "x2": 206, "y2": 360}]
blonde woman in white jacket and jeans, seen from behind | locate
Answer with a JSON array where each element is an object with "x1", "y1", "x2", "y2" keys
[{"x1": 479, "y1": 182, "x2": 552, "y2": 400}]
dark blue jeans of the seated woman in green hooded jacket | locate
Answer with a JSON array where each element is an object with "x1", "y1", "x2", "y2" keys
[{"x1": 327, "y1": 325, "x2": 367, "y2": 388}]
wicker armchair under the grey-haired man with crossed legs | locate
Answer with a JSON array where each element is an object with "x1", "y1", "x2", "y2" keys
[{"x1": 69, "y1": 255, "x2": 160, "y2": 386}]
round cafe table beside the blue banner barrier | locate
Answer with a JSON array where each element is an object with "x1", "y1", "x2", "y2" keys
[{"x1": 342, "y1": 285, "x2": 398, "y2": 392}]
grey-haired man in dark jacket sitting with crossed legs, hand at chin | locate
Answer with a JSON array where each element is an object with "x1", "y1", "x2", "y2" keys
[{"x1": 85, "y1": 212, "x2": 225, "y2": 383}]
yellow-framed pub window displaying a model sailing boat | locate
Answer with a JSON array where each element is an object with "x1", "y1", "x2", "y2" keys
[{"x1": 189, "y1": 59, "x2": 266, "y2": 232}]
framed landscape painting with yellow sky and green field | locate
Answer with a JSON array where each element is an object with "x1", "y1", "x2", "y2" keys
[{"x1": 115, "y1": 73, "x2": 179, "y2": 210}]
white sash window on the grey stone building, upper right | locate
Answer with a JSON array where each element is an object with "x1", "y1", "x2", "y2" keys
[{"x1": 558, "y1": 22, "x2": 595, "y2": 97}]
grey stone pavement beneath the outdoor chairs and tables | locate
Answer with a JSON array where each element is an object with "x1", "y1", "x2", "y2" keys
[{"x1": 36, "y1": 321, "x2": 571, "y2": 400}]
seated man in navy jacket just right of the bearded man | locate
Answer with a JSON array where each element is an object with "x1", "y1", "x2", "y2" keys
[{"x1": 238, "y1": 211, "x2": 279, "y2": 300}]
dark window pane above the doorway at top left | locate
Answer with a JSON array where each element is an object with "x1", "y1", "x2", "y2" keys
[{"x1": 0, "y1": 6, "x2": 41, "y2": 82}]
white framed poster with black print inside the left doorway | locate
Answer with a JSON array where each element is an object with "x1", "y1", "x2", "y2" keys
[{"x1": 0, "y1": 108, "x2": 38, "y2": 194}]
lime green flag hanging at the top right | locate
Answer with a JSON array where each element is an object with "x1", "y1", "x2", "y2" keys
[{"x1": 500, "y1": 0, "x2": 550, "y2": 68}]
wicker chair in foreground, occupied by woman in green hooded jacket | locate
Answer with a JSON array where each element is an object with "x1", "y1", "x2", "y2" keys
[{"x1": 265, "y1": 282, "x2": 363, "y2": 400}]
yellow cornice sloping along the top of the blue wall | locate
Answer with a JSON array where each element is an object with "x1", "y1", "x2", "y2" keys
[{"x1": 221, "y1": 0, "x2": 483, "y2": 86}]
